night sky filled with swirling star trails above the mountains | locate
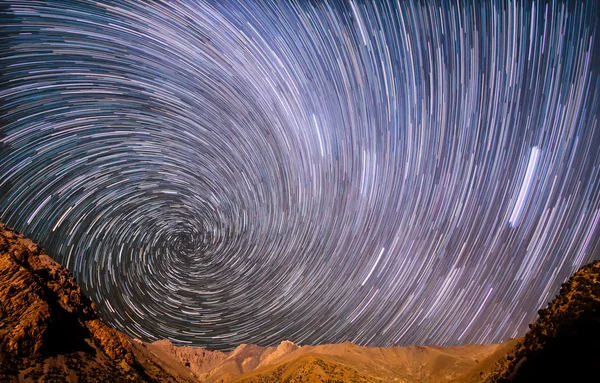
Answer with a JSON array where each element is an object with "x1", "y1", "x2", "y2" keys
[{"x1": 0, "y1": 0, "x2": 600, "y2": 350}]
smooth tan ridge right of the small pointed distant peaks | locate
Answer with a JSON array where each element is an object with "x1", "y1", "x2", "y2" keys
[{"x1": 230, "y1": 343, "x2": 516, "y2": 383}]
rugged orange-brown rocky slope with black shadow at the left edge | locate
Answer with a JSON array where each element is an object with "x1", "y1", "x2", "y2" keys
[{"x1": 0, "y1": 224, "x2": 195, "y2": 382}]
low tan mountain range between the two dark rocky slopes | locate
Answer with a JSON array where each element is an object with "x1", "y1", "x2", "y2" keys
[{"x1": 146, "y1": 341, "x2": 508, "y2": 383}]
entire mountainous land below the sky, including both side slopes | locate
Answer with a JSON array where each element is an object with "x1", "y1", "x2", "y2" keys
[{"x1": 0, "y1": 224, "x2": 600, "y2": 383}]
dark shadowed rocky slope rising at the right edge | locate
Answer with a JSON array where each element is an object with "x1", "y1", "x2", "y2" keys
[{"x1": 487, "y1": 261, "x2": 600, "y2": 383}]
